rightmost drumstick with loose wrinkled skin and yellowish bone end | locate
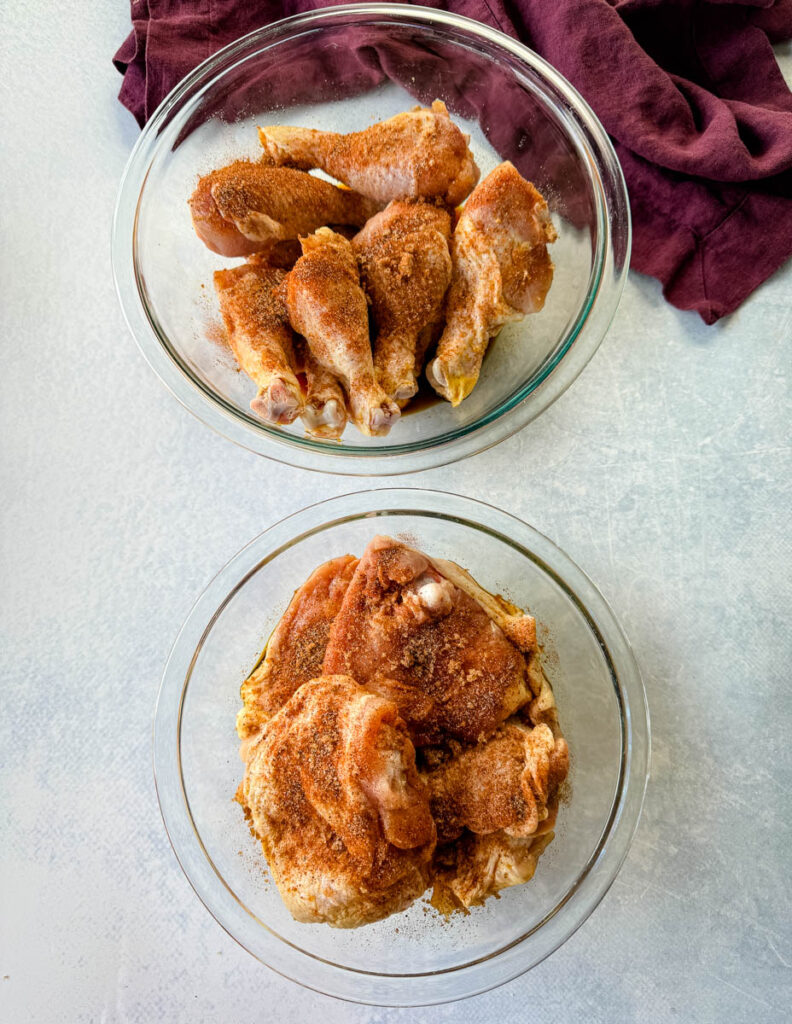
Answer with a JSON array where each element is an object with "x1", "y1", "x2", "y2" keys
[{"x1": 426, "y1": 162, "x2": 556, "y2": 406}]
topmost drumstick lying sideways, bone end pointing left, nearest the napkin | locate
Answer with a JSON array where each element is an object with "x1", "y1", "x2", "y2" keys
[{"x1": 258, "y1": 99, "x2": 478, "y2": 207}]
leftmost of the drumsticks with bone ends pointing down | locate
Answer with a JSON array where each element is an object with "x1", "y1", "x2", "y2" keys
[{"x1": 214, "y1": 262, "x2": 303, "y2": 423}]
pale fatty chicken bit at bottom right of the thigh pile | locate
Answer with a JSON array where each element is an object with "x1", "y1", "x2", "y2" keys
[{"x1": 431, "y1": 831, "x2": 553, "y2": 914}]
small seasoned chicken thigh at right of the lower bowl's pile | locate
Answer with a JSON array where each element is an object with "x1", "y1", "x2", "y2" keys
[{"x1": 424, "y1": 718, "x2": 569, "y2": 843}]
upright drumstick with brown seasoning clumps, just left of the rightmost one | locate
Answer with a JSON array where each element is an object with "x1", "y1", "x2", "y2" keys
[{"x1": 352, "y1": 200, "x2": 451, "y2": 406}]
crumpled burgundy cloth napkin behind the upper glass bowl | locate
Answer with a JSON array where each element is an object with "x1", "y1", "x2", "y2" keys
[{"x1": 115, "y1": 0, "x2": 792, "y2": 324}]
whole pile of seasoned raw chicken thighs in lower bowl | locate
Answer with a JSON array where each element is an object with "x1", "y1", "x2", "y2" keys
[{"x1": 237, "y1": 537, "x2": 569, "y2": 928}]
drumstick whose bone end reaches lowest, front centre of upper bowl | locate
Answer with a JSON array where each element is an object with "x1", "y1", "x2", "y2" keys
[{"x1": 286, "y1": 227, "x2": 400, "y2": 435}]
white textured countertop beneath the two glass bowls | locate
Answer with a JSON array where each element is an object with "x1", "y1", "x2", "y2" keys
[{"x1": 0, "y1": 8, "x2": 792, "y2": 1024}]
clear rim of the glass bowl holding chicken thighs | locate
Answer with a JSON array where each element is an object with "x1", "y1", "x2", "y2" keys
[{"x1": 153, "y1": 487, "x2": 651, "y2": 1006}]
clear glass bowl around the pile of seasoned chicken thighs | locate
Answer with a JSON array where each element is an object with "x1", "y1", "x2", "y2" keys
[{"x1": 154, "y1": 488, "x2": 650, "y2": 1006}]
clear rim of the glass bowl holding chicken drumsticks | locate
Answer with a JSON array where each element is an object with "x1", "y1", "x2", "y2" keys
[{"x1": 111, "y1": 3, "x2": 631, "y2": 476}]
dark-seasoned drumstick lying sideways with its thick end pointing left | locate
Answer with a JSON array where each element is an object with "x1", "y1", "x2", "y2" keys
[{"x1": 190, "y1": 160, "x2": 380, "y2": 256}]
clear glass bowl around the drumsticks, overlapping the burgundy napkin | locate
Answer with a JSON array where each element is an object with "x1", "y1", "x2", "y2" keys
[{"x1": 113, "y1": 4, "x2": 630, "y2": 475}]
